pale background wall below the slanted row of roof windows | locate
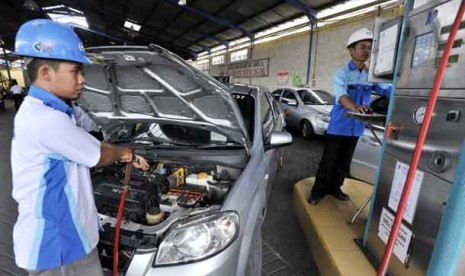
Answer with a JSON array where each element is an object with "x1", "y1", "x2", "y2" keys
[{"x1": 210, "y1": 4, "x2": 402, "y2": 93}]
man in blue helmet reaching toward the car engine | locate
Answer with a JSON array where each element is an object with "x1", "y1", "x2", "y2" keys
[{"x1": 11, "y1": 19, "x2": 148, "y2": 276}]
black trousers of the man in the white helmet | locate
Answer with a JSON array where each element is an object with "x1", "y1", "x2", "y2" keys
[{"x1": 312, "y1": 134, "x2": 358, "y2": 197}]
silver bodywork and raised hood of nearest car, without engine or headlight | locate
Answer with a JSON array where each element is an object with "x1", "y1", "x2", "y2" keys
[{"x1": 80, "y1": 47, "x2": 292, "y2": 276}]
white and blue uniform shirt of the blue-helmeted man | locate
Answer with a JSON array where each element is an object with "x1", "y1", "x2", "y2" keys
[{"x1": 11, "y1": 86, "x2": 100, "y2": 270}]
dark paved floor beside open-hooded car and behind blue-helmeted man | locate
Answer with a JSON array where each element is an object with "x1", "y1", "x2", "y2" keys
[{"x1": 0, "y1": 101, "x2": 324, "y2": 276}]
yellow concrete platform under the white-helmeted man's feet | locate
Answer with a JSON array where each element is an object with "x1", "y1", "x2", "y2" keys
[{"x1": 293, "y1": 178, "x2": 376, "y2": 276}]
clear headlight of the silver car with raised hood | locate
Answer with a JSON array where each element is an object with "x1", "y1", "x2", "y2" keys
[{"x1": 154, "y1": 211, "x2": 239, "y2": 265}]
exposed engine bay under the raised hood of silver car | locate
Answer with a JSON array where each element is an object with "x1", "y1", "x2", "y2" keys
[{"x1": 91, "y1": 160, "x2": 240, "y2": 273}]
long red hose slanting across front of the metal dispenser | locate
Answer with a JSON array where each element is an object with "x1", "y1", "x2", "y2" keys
[{"x1": 376, "y1": 0, "x2": 465, "y2": 276}]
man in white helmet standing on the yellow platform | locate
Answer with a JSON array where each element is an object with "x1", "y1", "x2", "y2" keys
[{"x1": 308, "y1": 28, "x2": 392, "y2": 204}]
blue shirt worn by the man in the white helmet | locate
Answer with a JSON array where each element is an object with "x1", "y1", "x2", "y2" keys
[{"x1": 327, "y1": 61, "x2": 392, "y2": 137}]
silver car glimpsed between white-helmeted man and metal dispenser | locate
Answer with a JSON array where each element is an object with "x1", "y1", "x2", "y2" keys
[{"x1": 350, "y1": 96, "x2": 388, "y2": 184}]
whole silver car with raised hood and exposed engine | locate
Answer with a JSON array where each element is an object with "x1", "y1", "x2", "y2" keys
[{"x1": 79, "y1": 45, "x2": 292, "y2": 276}]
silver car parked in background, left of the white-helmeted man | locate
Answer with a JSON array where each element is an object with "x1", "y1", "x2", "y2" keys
[{"x1": 273, "y1": 88, "x2": 333, "y2": 139}]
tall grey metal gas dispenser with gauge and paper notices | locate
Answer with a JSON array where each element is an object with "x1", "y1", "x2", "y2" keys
[{"x1": 362, "y1": 0, "x2": 465, "y2": 275}]
